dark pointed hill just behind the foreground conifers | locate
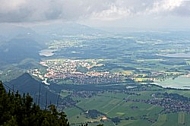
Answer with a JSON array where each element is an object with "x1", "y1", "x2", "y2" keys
[{"x1": 6, "y1": 73, "x2": 61, "y2": 107}]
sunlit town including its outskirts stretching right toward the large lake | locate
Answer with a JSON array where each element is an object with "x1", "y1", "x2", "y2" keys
[{"x1": 28, "y1": 59, "x2": 184, "y2": 84}]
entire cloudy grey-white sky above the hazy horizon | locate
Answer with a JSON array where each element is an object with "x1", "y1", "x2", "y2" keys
[{"x1": 0, "y1": 0, "x2": 190, "y2": 29}]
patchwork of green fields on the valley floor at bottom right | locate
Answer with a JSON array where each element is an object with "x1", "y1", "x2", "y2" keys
[{"x1": 64, "y1": 90, "x2": 190, "y2": 126}]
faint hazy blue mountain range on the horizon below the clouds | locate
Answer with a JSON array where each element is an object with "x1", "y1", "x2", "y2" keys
[{"x1": 0, "y1": 23, "x2": 105, "y2": 41}]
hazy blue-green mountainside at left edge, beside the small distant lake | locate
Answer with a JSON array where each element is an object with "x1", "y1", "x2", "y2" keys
[{"x1": 0, "y1": 38, "x2": 41, "y2": 64}]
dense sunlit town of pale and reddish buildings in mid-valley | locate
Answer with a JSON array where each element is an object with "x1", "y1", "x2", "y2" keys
[{"x1": 29, "y1": 59, "x2": 123, "y2": 84}]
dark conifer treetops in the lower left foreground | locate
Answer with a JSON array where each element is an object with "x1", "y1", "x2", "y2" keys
[{"x1": 0, "y1": 81, "x2": 69, "y2": 126}]
